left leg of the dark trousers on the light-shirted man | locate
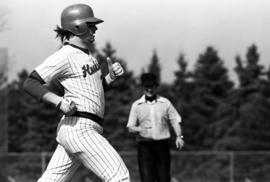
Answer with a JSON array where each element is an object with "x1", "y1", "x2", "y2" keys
[{"x1": 137, "y1": 141, "x2": 156, "y2": 182}]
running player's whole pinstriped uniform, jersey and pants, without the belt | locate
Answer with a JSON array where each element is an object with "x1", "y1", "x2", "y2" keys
[{"x1": 35, "y1": 45, "x2": 130, "y2": 182}]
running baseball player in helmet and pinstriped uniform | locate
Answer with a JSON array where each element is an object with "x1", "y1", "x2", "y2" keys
[{"x1": 24, "y1": 4, "x2": 130, "y2": 182}]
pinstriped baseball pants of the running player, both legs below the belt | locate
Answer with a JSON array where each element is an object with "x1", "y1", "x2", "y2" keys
[{"x1": 38, "y1": 117, "x2": 130, "y2": 182}]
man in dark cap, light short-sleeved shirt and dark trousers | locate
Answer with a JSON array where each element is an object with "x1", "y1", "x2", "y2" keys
[{"x1": 127, "y1": 73, "x2": 184, "y2": 182}]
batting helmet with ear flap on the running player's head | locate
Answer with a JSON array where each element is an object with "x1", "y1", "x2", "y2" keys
[{"x1": 61, "y1": 4, "x2": 103, "y2": 36}]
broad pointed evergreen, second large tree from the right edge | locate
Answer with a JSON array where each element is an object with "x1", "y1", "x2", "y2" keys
[{"x1": 186, "y1": 47, "x2": 233, "y2": 150}]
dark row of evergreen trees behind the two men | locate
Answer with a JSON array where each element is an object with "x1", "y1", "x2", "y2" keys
[{"x1": 0, "y1": 43, "x2": 270, "y2": 152}]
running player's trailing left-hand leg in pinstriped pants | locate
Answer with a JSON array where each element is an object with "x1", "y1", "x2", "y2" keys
[{"x1": 38, "y1": 145, "x2": 80, "y2": 182}]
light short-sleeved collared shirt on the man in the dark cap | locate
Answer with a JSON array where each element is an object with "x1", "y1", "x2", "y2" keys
[{"x1": 127, "y1": 95, "x2": 181, "y2": 140}]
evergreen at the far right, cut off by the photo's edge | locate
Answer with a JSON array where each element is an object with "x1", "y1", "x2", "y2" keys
[{"x1": 217, "y1": 45, "x2": 270, "y2": 150}]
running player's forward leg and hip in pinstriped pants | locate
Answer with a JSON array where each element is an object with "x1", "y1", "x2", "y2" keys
[{"x1": 58, "y1": 117, "x2": 130, "y2": 182}]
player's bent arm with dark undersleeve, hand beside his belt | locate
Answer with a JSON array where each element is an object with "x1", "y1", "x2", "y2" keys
[{"x1": 23, "y1": 71, "x2": 77, "y2": 115}]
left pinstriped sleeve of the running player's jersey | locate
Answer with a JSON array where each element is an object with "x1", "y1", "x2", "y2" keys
[{"x1": 34, "y1": 54, "x2": 69, "y2": 82}]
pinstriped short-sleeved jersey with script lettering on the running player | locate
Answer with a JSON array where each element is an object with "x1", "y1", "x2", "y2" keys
[{"x1": 35, "y1": 45, "x2": 105, "y2": 118}]
